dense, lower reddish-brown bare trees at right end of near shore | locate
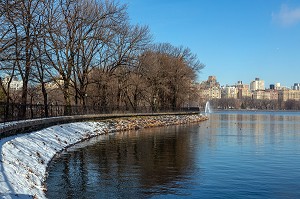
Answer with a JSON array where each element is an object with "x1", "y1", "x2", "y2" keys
[{"x1": 88, "y1": 43, "x2": 203, "y2": 111}]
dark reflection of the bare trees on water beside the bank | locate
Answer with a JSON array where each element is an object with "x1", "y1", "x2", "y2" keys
[{"x1": 48, "y1": 127, "x2": 199, "y2": 198}]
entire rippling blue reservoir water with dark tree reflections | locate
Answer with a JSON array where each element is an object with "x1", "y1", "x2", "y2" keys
[{"x1": 46, "y1": 111, "x2": 300, "y2": 198}]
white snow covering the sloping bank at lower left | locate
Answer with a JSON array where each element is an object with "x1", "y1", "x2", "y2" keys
[{"x1": 0, "y1": 122, "x2": 112, "y2": 198}]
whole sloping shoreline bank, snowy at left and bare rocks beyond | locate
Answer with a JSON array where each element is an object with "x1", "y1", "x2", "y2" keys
[{"x1": 0, "y1": 114, "x2": 208, "y2": 198}]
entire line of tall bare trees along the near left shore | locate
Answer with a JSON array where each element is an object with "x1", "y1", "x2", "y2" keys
[{"x1": 0, "y1": 0, "x2": 203, "y2": 118}]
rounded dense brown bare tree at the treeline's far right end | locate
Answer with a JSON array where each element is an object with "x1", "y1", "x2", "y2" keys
[{"x1": 140, "y1": 44, "x2": 204, "y2": 110}]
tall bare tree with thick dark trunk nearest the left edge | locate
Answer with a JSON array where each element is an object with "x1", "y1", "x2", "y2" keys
[{"x1": 1, "y1": 0, "x2": 41, "y2": 118}]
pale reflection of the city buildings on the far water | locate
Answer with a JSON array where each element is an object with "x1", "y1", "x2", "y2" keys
[{"x1": 207, "y1": 111, "x2": 300, "y2": 145}]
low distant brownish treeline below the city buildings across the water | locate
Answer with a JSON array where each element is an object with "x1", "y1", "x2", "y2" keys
[{"x1": 210, "y1": 97, "x2": 300, "y2": 110}]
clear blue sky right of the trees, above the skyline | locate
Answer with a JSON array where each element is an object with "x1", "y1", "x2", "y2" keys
[{"x1": 120, "y1": 0, "x2": 300, "y2": 87}]
